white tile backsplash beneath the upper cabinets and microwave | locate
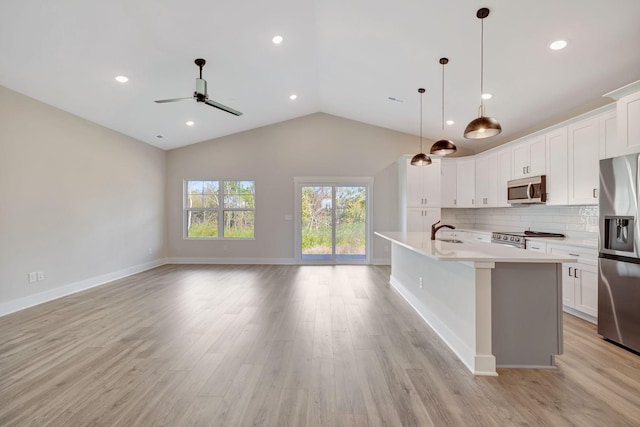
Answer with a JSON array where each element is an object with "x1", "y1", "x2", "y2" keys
[{"x1": 442, "y1": 205, "x2": 598, "y2": 238}]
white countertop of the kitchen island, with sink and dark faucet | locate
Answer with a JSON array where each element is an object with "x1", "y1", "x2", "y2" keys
[{"x1": 375, "y1": 231, "x2": 577, "y2": 263}]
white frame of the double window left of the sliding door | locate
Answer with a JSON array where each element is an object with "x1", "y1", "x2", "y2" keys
[{"x1": 182, "y1": 178, "x2": 256, "y2": 241}]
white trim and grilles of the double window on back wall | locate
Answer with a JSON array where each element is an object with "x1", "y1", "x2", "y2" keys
[{"x1": 182, "y1": 178, "x2": 257, "y2": 242}]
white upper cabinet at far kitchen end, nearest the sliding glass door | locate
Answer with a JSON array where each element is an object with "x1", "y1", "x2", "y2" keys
[{"x1": 401, "y1": 159, "x2": 440, "y2": 207}]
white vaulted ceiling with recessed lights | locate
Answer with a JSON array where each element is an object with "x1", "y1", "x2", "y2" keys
[{"x1": 0, "y1": 0, "x2": 640, "y2": 151}]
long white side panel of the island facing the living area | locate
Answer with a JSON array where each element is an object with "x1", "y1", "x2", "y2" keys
[{"x1": 391, "y1": 243, "x2": 495, "y2": 375}]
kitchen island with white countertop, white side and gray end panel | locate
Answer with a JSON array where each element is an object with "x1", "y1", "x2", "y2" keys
[{"x1": 375, "y1": 232, "x2": 575, "y2": 375}]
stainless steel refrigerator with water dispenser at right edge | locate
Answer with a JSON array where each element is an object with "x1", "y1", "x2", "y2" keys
[{"x1": 598, "y1": 154, "x2": 640, "y2": 352}]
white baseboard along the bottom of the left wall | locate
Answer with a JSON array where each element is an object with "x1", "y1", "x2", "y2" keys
[{"x1": 0, "y1": 258, "x2": 167, "y2": 316}]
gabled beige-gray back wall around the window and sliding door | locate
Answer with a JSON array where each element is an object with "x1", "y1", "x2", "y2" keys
[{"x1": 167, "y1": 113, "x2": 431, "y2": 263}]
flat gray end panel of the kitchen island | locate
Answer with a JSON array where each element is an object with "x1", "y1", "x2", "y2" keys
[{"x1": 491, "y1": 263, "x2": 562, "y2": 367}]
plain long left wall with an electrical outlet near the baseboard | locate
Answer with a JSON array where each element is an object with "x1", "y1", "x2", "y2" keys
[{"x1": 0, "y1": 86, "x2": 166, "y2": 315}]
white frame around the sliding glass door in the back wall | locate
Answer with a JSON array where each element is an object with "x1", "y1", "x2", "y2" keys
[{"x1": 293, "y1": 176, "x2": 373, "y2": 264}]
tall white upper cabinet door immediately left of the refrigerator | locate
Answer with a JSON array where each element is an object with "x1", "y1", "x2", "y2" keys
[{"x1": 567, "y1": 117, "x2": 600, "y2": 205}]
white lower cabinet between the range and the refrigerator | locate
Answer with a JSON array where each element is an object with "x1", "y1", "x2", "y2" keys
[{"x1": 548, "y1": 243, "x2": 598, "y2": 318}]
